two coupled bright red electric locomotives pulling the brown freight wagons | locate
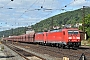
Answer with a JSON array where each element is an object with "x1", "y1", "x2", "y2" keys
[{"x1": 35, "y1": 28, "x2": 81, "y2": 47}]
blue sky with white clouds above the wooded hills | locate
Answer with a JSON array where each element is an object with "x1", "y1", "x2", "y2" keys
[{"x1": 0, "y1": 0, "x2": 90, "y2": 31}]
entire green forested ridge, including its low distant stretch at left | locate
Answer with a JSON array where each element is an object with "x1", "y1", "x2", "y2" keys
[{"x1": 0, "y1": 8, "x2": 90, "y2": 37}]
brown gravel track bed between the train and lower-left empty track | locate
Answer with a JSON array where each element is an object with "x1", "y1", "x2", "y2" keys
[{"x1": 3, "y1": 43, "x2": 90, "y2": 60}]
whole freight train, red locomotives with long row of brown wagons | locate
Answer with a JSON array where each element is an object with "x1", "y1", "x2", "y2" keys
[{"x1": 3, "y1": 28, "x2": 81, "y2": 48}]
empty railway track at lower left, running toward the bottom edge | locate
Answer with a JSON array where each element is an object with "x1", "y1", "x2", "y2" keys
[{"x1": 4, "y1": 44, "x2": 45, "y2": 60}]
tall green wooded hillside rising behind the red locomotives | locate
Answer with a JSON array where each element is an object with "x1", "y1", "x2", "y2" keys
[{"x1": 32, "y1": 8, "x2": 90, "y2": 32}]
